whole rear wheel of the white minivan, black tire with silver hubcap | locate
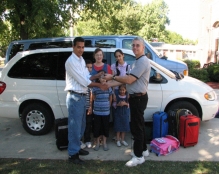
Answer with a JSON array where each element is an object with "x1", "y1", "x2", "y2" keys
[{"x1": 22, "y1": 103, "x2": 52, "y2": 135}]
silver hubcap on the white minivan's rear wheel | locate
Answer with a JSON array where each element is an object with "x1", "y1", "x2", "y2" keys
[{"x1": 26, "y1": 110, "x2": 45, "y2": 131}]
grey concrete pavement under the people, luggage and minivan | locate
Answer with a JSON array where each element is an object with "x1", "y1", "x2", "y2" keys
[{"x1": 0, "y1": 117, "x2": 219, "y2": 161}]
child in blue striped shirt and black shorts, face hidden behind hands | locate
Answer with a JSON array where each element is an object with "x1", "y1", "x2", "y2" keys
[{"x1": 92, "y1": 70, "x2": 113, "y2": 151}]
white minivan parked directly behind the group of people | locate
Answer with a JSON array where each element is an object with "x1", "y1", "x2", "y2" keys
[{"x1": 0, "y1": 48, "x2": 218, "y2": 135}]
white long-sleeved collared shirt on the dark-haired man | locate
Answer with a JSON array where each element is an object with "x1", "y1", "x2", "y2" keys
[{"x1": 65, "y1": 53, "x2": 91, "y2": 93}]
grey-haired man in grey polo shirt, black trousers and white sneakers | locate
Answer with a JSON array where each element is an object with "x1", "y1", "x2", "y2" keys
[{"x1": 104, "y1": 37, "x2": 151, "y2": 167}]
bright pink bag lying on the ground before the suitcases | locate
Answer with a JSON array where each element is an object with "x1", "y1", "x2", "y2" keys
[{"x1": 150, "y1": 135, "x2": 180, "y2": 156}]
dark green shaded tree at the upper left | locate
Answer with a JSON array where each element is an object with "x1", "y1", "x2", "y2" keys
[{"x1": 0, "y1": 0, "x2": 104, "y2": 54}]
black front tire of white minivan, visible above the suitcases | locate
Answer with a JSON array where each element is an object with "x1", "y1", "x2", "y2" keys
[{"x1": 167, "y1": 101, "x2": 200, "y2": 117}]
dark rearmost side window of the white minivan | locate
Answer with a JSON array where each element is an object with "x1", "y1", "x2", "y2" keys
[{"x1": 8, "y1": 53, "x2": 58, "y2": 80}]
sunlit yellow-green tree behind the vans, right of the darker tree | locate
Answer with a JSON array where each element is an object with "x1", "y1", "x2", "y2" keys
[{"x1": 76, "y1": 0, "x2": 169, "y2": 39}]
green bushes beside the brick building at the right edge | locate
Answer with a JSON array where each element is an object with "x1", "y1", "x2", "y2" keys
[{"x1": 184, "y1": 60, "x2": 219, "y2": 82}]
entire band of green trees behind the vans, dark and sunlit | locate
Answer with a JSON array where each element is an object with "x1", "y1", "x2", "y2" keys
[{"x1": 0, "y1": 0, "x2": 198, "y2": 56}]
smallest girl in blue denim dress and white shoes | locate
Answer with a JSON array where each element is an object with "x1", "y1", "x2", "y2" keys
[{"x1": 113, "y1": 85, "x2": 130, "y2": 147}]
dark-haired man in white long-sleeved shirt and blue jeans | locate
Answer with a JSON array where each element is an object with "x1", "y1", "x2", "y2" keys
[{"x1": 65, "y1": 37, "x2": 106, "y2": 164}]
